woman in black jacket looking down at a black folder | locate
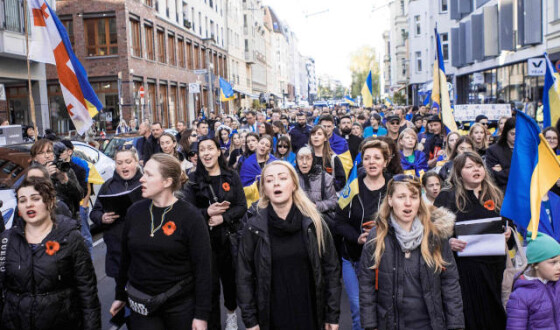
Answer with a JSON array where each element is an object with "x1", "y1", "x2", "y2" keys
[{"x1": 89, "y1": 144, "x2": 142, "y2": 278}]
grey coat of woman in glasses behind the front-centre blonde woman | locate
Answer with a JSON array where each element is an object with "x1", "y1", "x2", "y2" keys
[{"x1": 299, "y1": 173, "x2": 338, "y2": 213}]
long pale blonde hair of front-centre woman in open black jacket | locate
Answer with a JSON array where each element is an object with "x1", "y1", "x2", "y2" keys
[{"x1": 257, "y1": 160, "x2": 328, "y2": 255}]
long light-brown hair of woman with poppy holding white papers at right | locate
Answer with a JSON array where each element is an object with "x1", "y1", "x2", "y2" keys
[{"x1": 449, "y1": 151, "x2": 504, "y2": 212}]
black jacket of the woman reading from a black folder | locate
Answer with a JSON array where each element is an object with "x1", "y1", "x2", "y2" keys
[{"x1": 89, "y1": 169, "x2": 142, "y2": 278}]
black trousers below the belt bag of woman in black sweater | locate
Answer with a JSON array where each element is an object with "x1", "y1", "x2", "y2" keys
[{"x1": 127, "y1": 296, "x2": 194, "y2": 330}]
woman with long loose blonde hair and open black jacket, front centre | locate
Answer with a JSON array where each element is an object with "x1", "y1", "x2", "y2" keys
[{"x1": 237, "y1": 161, "x2": 341, "y2": 330}]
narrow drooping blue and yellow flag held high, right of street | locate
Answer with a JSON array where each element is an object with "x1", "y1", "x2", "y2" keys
[{"x1": 432, "y1": 28, "x2": 457, "y2": 132}]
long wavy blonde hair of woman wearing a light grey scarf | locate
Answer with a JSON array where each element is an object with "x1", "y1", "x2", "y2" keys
[{"x1": 366, "y1": 175, "x2": 447, "y2": 272}]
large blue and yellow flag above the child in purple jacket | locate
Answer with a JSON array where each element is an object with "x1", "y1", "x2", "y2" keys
[{"x1": 501, "y1": 111, "x2": 560, "y2": 239}]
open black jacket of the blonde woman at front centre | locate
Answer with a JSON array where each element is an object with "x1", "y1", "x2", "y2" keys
[{"x1": 237, "y1": 208, "x2": 341, "y2": 330}]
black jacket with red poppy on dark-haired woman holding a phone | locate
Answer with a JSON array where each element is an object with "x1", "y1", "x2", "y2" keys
[{"x1": 183, "y1": 170, "x2": 247, "y2": 242}]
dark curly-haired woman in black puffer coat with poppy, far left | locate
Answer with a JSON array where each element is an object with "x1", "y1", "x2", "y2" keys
[{"x1": 0, "y1": 177, "x2": 101, "y2": 329}]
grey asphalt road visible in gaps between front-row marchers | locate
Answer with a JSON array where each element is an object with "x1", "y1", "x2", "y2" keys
[{"x1": 93, "y1": 234, "x2": 352, "y2": 330}]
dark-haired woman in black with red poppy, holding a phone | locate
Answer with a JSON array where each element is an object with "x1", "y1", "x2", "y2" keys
[{"x1": 183, "y1": 137, "x2": 247, "y2": 329}]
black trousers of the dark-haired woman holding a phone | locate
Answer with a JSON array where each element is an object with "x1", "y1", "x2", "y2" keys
[{"x1": 208, "y1": 239, "x2": 237, "y2": 330}]
